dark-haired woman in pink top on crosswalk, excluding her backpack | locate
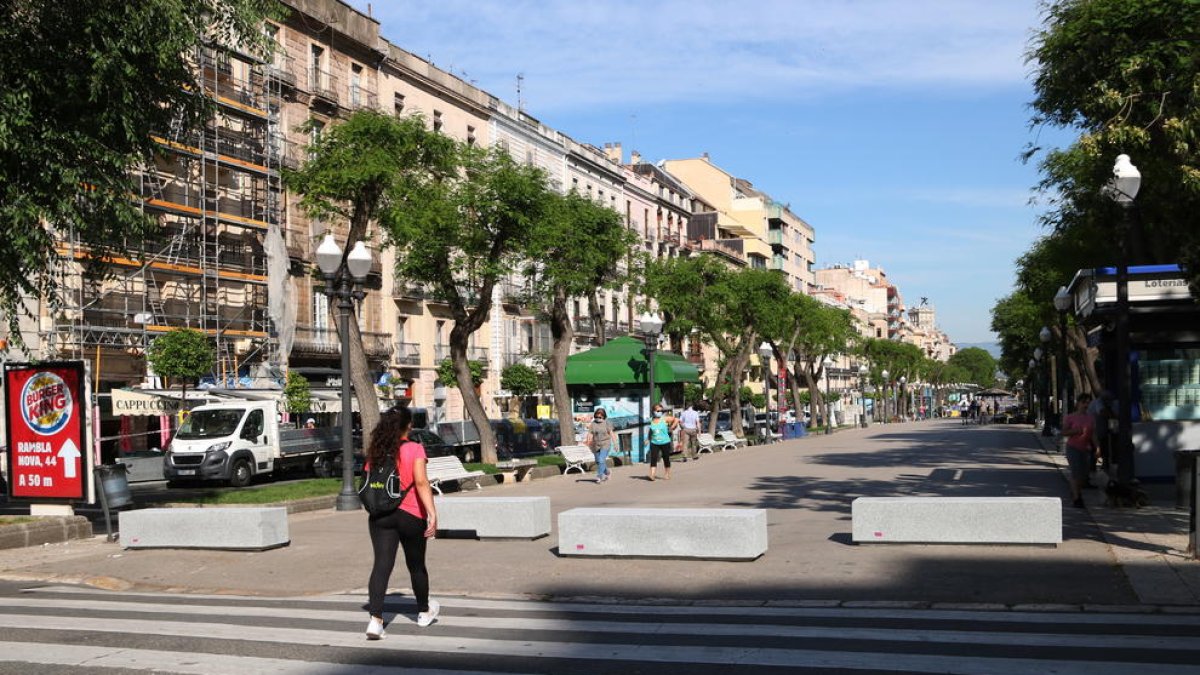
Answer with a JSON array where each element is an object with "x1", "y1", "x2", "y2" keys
[{"x1": 366, "y1": 407, "x2": 440, "y2": 640}]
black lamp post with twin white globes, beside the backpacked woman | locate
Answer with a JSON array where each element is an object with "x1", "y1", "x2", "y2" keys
[{"x1": 317, "y1": 233, "x2": 374, "y2": 510}]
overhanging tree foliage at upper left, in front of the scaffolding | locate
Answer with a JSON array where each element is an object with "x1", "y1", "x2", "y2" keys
[{"x1": 0, "y1": 0, "x2": 278, "y2": 341}]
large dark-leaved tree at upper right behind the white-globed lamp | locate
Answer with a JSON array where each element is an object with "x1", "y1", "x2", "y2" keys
[{"x1": 1026, "y1": 0, "x2": 1200, "y2": 298}]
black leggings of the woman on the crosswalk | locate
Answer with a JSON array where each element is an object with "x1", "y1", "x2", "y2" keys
[{"x1": 367, "y1": 509, "x2": 430, "y2": 616}]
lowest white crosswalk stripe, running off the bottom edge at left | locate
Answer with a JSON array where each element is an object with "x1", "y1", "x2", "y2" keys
[{"x1": 0, "y1": 641, "x2": 488, "y2": 675}]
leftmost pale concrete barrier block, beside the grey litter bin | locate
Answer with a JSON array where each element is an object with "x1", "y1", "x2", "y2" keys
[{"x1": 120, "y1": 507, "x2": 290, "y2": 550}]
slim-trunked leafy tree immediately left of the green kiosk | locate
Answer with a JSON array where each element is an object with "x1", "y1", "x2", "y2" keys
[{"x1": 526, "y1": 191, "x2": 636, "y2": 449}]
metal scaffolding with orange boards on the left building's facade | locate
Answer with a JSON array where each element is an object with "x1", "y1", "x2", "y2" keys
[{"x1": 50, "y1": 46, "x2": 283, "y2": 383}]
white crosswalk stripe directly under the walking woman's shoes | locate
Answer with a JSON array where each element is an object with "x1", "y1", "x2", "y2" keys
[{"x1": 0, "y1": 607, "x2": 1195, "y2": 675}]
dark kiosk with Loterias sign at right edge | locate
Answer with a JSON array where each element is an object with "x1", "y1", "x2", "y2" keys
[{"x1": 1068, "y1": 264, "x2": 1200, "y2": 480}]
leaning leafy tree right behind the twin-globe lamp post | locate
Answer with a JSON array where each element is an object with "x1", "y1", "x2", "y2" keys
[{"x1": 283, "y1": 110, "x2": 458, "y2": 446}]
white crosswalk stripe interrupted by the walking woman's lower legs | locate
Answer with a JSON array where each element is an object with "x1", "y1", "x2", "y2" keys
[{"x1": 0, "y1": 598, "x2": 1200, "y2": 651}]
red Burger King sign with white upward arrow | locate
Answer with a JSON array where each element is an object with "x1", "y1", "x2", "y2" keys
[{"x1": 4, "y1": 362, "x2": 88, "y2": 500}]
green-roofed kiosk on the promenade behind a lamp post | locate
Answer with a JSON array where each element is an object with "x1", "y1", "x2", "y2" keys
[{"x1": 566, "y1": 338, "x2": 700, "y2": 462}]
